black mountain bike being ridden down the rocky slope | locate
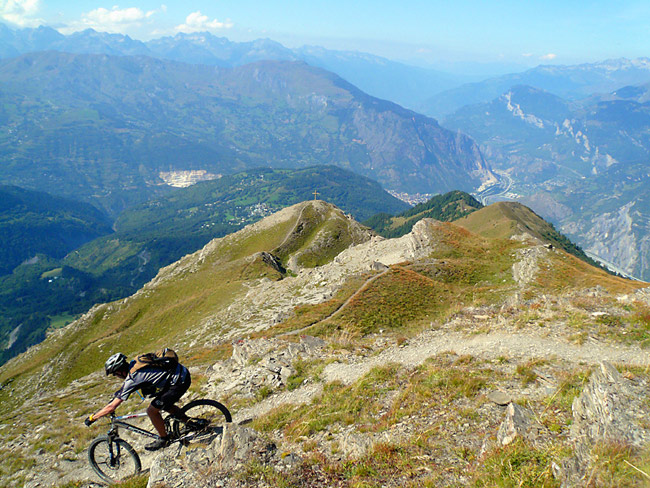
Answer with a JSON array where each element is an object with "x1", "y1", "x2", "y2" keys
[{"x1": 88, "y1": 399, "x2": 232, "y2": 483}]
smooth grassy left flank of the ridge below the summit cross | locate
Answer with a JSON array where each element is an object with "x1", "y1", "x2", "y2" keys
[{"x1": 0, "y1": 202, "x2": 362, "y2": 394}]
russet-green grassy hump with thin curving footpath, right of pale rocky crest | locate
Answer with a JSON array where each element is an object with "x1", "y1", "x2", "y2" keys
[{"x1": 332, "y1": 222, "x2": 521, "y2": 336}]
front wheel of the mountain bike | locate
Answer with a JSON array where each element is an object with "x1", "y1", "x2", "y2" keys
[{"x1": 88, "y1": 435, "x2": 142, "y2": 483}]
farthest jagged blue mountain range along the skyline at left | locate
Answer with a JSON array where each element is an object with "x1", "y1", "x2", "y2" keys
[{"x1": 0, "y1": 24, "x2": 468, "y2": 108}]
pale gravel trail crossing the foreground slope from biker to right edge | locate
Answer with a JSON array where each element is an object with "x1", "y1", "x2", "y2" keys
[{"x1": 235, "y1": 330, "x2": 650, "y2": 421}]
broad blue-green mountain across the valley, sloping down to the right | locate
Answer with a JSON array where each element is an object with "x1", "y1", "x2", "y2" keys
[{"x1": 0, "y1": 51, "x2": 491, "y2": 213}]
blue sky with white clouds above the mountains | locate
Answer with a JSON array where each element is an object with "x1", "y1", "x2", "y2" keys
[{"x1": 0, "y1": 0, "x2": 650, "y2": 71}]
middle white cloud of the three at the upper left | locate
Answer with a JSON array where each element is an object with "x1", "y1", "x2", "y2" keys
[{"x1": 59, "y1": 6, "x2": 157, "y2": 34}]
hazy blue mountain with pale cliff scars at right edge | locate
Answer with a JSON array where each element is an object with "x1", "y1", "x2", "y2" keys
[{"x1": 445, "y1": 85, "x2": 650, "y2": 279}]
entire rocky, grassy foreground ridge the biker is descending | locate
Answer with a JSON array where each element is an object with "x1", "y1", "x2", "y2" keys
[{"x1": 0, "y1": 201, "x2": 650, "y2": 488}]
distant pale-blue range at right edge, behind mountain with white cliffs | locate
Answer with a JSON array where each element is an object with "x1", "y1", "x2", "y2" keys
[{"x1": 419, "y1": 58, "x2": 650, "y2": 119}]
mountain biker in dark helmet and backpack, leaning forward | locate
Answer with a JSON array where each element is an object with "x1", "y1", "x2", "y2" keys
[{"x1": 84, "y1": 352, "x2": 192, "y2": 451}]
